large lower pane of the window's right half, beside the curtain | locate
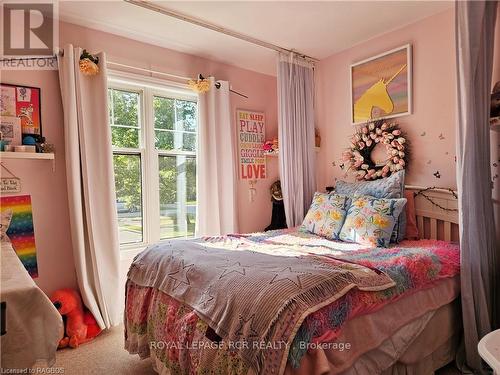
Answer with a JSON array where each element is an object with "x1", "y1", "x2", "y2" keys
[{"x1": 158, "y1": 155, "x2": 196, "y2": 239}]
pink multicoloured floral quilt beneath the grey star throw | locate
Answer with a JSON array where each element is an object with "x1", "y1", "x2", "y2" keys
[{"x1": 125, "y1": 229, "x2": 459, "y2": 374}]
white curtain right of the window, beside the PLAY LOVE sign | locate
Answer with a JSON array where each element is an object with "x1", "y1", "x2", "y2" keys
[{"x1": 196, "y1": 77, "x2": 238, "y2": 236}]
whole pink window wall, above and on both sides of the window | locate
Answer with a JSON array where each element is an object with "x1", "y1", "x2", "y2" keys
[{"x1": 1, "y1": 23, "x2": 278, "y2": 293}]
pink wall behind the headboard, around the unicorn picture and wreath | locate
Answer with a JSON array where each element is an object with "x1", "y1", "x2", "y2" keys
[{"x1": 316, "y1": 11, "x2": 456, "y2": 190}]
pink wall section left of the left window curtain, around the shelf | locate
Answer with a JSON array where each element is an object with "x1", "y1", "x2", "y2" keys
[{"x1": 1, "y1": 71, "x2": 76, "y2": 293}]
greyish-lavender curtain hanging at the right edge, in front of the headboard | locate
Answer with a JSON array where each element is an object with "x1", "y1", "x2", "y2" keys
[{"x1": 455, "y1": 1, "x2": 500, "y2": 373}]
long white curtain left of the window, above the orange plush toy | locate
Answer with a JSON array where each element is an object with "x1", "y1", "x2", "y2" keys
[{"x1": 58, "y1": 45, "x2": 123, "y2": 328}]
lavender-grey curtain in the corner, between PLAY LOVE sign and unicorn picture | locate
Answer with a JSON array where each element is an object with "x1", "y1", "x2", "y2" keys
[{"x1": 278, "y1": 54, "x2": 316, "y2": 228}]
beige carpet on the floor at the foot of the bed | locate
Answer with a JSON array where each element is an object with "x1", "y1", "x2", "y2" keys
[{"x1": 54, "y1": 325, "x2": 459, "y2": 375}]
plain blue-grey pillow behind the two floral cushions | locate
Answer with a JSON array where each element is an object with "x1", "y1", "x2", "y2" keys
[{"x1": 335, "y1": 170, "x2": 406, "y2": 242}]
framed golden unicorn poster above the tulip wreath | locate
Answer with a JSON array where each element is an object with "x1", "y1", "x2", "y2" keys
[{"x1": 351, "y1": 44, "x2": 412, "y2": 124}]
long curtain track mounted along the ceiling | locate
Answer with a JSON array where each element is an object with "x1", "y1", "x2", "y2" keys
[{"x1": 123, "y1": 0, "x2": 319, "y2": 62}]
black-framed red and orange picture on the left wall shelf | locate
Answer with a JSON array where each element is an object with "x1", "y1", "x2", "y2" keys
[{"x1": 0, "y1": 83, "x2": 42, "y2": 139}]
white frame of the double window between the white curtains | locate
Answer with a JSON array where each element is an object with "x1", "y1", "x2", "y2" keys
[{"x1": 108, "y1": 71, "x2": 199, "y2": 259}]
